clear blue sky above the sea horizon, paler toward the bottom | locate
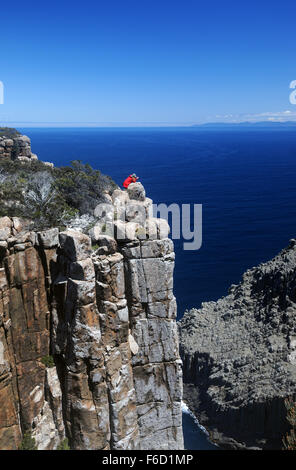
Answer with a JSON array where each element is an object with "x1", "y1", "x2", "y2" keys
[{"x1": 0, "y1": 0, "x2": 296, "y2": 125}]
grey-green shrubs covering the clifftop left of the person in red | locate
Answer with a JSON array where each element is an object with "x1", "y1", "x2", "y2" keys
[{"x1": 0, "y1": 159, "x2": 117, "y2": 230}]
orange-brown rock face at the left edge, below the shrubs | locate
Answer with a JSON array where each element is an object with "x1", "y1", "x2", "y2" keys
[{"x1": 0, "y1": 217, "x2": 64, "y2": 449}]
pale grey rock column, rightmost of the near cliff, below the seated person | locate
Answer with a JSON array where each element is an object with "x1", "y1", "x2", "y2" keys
[{"x1": 121, "y1": 239, "x2": 184, "y2": 450}]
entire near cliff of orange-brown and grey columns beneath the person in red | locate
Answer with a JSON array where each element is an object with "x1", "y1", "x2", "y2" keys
[{"x1": 0, "y1": 184, "x2": 183, "y2": 449}]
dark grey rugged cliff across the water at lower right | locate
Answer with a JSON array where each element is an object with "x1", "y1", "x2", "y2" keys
[{"x1": 179, "y1": 240, "x2": 296, "y2": 449}]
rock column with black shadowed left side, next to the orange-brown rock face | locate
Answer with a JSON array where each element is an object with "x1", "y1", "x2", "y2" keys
[{"x1": 52, "y1": 231, "x2": 110, "y2": 450}]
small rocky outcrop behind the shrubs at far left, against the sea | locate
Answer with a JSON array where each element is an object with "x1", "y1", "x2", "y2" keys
[{"x1": 0, "y1": 134, "x2": 38, "y2": 162}]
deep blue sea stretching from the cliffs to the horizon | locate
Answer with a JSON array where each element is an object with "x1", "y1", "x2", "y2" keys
[{"x1": 22, "y1": 128, "x2": 296, "y2": 316}]
